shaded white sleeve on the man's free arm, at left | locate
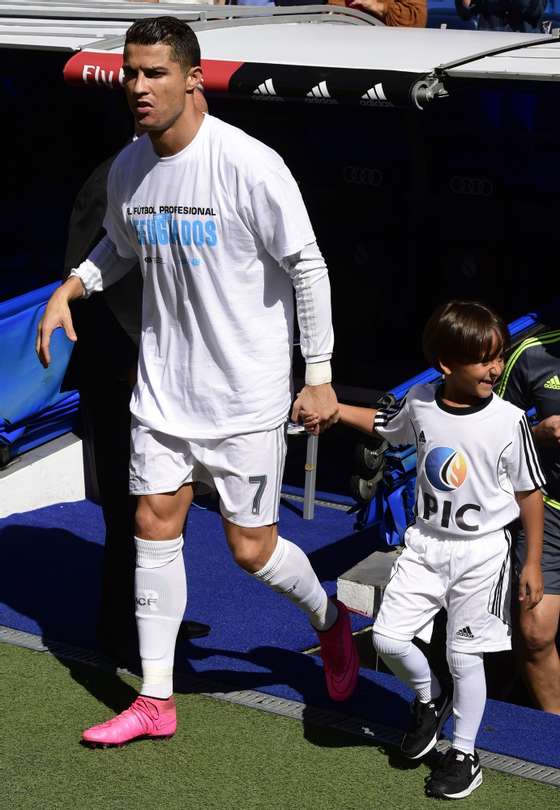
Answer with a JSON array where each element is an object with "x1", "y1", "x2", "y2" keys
[{"x1": 70, "y1": 158, "x2": 138, "y2": 298}]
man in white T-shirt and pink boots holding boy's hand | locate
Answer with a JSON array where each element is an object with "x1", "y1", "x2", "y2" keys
[{"x1": 37, "y1": 17, "x2": 359, "y2": 745}]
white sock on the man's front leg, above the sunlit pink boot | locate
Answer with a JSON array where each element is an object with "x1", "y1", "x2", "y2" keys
[{"x1": 134, "y1": 536, "x2": 187, "y2": 699}]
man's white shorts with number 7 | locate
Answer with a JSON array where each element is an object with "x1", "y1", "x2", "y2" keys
[{"x1": 130, "y1": 418, "x2": 286, "y2": 527}]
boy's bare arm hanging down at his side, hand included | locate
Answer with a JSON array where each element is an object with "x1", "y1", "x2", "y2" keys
[{"x1": 515, "y1": 489, "x2": 544, "y2": 610}]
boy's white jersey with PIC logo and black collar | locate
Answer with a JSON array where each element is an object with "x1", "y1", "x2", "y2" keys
[{"x1": 374, "y1": 383, "x2": 544, "y2": 539}]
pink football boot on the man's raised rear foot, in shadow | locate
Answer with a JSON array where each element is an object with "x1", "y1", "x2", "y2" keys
[{"x1": 318, "y1": 599, "x2": 360, "y2": 700}]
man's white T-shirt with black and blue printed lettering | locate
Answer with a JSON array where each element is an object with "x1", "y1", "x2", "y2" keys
[{"x1": 95, "y1": 115, "x2": 320, "y2": 439}]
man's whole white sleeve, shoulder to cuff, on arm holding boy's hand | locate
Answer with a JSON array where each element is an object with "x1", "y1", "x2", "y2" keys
[{"x1": 251, "y1": 164, "x2": 334, "y2": 385}]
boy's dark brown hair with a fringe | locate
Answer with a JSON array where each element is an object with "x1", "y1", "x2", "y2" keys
[{"x1": 422, "y1": 301, "x2": 509, "y2": 368}]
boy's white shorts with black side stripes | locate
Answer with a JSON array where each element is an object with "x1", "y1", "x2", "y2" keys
[{"x1": 374, "y1": 526, "x2": 511, "y2": 652}]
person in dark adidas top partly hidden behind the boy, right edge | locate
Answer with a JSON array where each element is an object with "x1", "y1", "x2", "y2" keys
[{"x1": 497, "y1": 330, "x2": 560, "y2": 714}]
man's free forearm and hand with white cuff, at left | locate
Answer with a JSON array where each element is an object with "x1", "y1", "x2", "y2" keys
[{"x1": 35, "y1": 236, "x2": 137, "y2": 368}]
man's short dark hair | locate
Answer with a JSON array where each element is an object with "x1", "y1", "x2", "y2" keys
[{"x1": 124, "y1": 17, "x2": 200, "y2": 73}]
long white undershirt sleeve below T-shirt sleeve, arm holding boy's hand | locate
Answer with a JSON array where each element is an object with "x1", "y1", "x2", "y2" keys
[{"x1": 280, "y1": 242, "x2": 334, "y2": 378}]
